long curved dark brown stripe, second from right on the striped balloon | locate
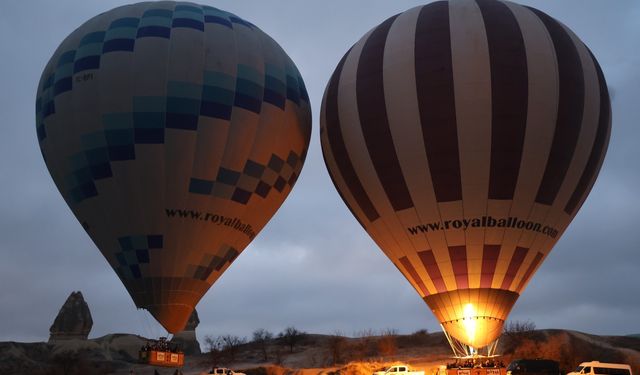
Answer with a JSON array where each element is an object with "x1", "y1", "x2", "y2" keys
[{"x1": 529, "y1": 8, "x2": 584, "y2": 205}]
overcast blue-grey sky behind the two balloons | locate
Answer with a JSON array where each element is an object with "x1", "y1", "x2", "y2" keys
[{"x1": 0, "y1": 0, "x2": 640, "y2": 341}]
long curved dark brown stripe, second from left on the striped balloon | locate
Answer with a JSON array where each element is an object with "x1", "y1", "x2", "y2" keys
[{"x1": 356, "y1": 15, "x2": 413, "y2": 211}]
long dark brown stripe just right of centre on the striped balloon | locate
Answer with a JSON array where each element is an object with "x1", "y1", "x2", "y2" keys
[{"x1": 476, "y1": 0, "x2": 529, "y2": 199}]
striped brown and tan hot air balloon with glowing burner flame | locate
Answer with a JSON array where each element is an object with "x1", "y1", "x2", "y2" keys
[{"x1": 321, "y1": 0, "x2": 611, "y2": 356}]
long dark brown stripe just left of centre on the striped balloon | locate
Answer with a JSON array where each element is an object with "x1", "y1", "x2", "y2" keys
[{"x1": 415, "y1": 1, "x2": 462, "y2": 202}]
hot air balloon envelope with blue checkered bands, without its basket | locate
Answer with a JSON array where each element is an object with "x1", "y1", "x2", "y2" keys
[{"x1": 36, "y1": 1, "x2": 311, "y2": 333}]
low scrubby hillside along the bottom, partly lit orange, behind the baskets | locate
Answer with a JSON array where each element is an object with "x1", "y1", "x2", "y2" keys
[{"x1": 0, "y1": 330, "x2": 640, "y2": 375}]
